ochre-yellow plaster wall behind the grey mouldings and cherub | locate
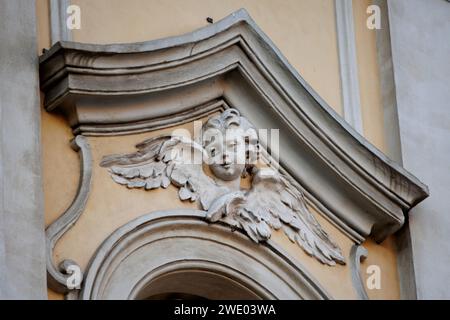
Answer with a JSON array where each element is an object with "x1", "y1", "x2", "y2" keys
[{"x1": 37, "y1": 0, "x2": 399, "y2": 299}]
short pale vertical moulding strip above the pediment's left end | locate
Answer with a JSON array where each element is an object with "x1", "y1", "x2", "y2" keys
[{"x1": 50, "y1": 0, "x2": 72, "y2": 45}]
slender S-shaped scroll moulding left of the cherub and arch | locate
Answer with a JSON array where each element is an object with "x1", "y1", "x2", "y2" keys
[{"x1": 45, "y1": 135, "x2": 92, "y2": 296}]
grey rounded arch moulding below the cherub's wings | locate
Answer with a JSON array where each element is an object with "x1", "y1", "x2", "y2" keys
[{"x1": 80, "y1": 210, "x2": 331, "y2": 300}]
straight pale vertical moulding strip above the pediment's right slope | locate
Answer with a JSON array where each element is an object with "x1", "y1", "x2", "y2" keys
[{"x1": 334, "y1": 0, "x2": 363, "y2": 135}]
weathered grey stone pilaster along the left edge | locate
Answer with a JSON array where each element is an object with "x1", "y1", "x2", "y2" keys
[{"x1": 0, "y1": 0, "x2": 47, "y2": 299}]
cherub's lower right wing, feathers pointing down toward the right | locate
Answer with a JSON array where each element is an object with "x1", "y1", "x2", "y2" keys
[{"x1": 207, "y1": 169, "x2": 345, "y2": 265}]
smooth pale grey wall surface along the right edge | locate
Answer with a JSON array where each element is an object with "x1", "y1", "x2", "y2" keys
[{"x1": 388, "y1": 0, "x2": 450, "y2": 299}]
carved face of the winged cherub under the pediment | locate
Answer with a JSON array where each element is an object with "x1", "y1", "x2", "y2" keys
[{"x1": 206, "y1": 126, "x2": 246, "y2": 181}]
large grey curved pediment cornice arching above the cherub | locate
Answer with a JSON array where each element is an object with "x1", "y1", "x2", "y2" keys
[{"x1": 40, "y1": 10, "x2": 428, "y2": 250}]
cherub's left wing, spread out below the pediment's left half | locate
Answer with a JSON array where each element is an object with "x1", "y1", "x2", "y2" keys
[{"x1": 100, "y1": 135, "x2": 230, "y2": 210}]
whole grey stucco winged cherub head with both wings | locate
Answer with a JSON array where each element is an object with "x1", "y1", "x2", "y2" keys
[{"x1": 101, "y1": 109, "x2": 345, "y2": 265}]
